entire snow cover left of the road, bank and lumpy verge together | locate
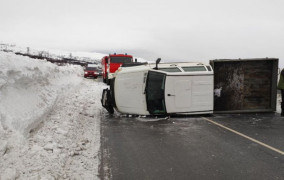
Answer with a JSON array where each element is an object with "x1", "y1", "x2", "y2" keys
[{"x1": 0, "y1": 52, "x2": 105, "y2": 180}]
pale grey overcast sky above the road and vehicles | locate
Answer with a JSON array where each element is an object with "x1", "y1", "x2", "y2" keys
[{"x1": 0, "y1": 0, "x2": 284, "y2": 66}]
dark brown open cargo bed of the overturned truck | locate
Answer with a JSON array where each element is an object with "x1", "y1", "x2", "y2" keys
[{"x1": 210, "y1": 58, "x2": 278, "y2": 113}]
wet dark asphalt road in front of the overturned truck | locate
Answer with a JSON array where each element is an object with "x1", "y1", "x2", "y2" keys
[{"x1": 100, "y1": 113, "x2": 284, "y2": 180}]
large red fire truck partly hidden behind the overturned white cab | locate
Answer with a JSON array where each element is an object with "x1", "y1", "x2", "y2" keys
[{"x1": 102, "y1": 53, "x2": 133, "y2": 84}]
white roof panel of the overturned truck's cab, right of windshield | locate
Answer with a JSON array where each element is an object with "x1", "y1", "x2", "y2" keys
[{"x1": 165, "y1": 75, "x2": 213, "y2": 113}]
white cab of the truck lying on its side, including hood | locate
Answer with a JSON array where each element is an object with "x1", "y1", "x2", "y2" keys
[{"x1": 101, "y1": 59, "x2": 214, "y2": 115}]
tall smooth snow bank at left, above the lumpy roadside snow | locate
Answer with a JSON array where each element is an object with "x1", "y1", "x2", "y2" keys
[{"x1": 0, "y1": 52, "x2": 83, "y2": 136}]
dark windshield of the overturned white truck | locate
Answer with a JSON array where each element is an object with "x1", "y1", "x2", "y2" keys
[{"x1": 146, "y1": 71, "x2": 166, "y2": 114}]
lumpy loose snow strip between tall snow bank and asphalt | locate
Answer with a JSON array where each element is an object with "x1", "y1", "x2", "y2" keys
[{"x1": 3, "y1": 79, "x2": 104, "y2": 179}]
